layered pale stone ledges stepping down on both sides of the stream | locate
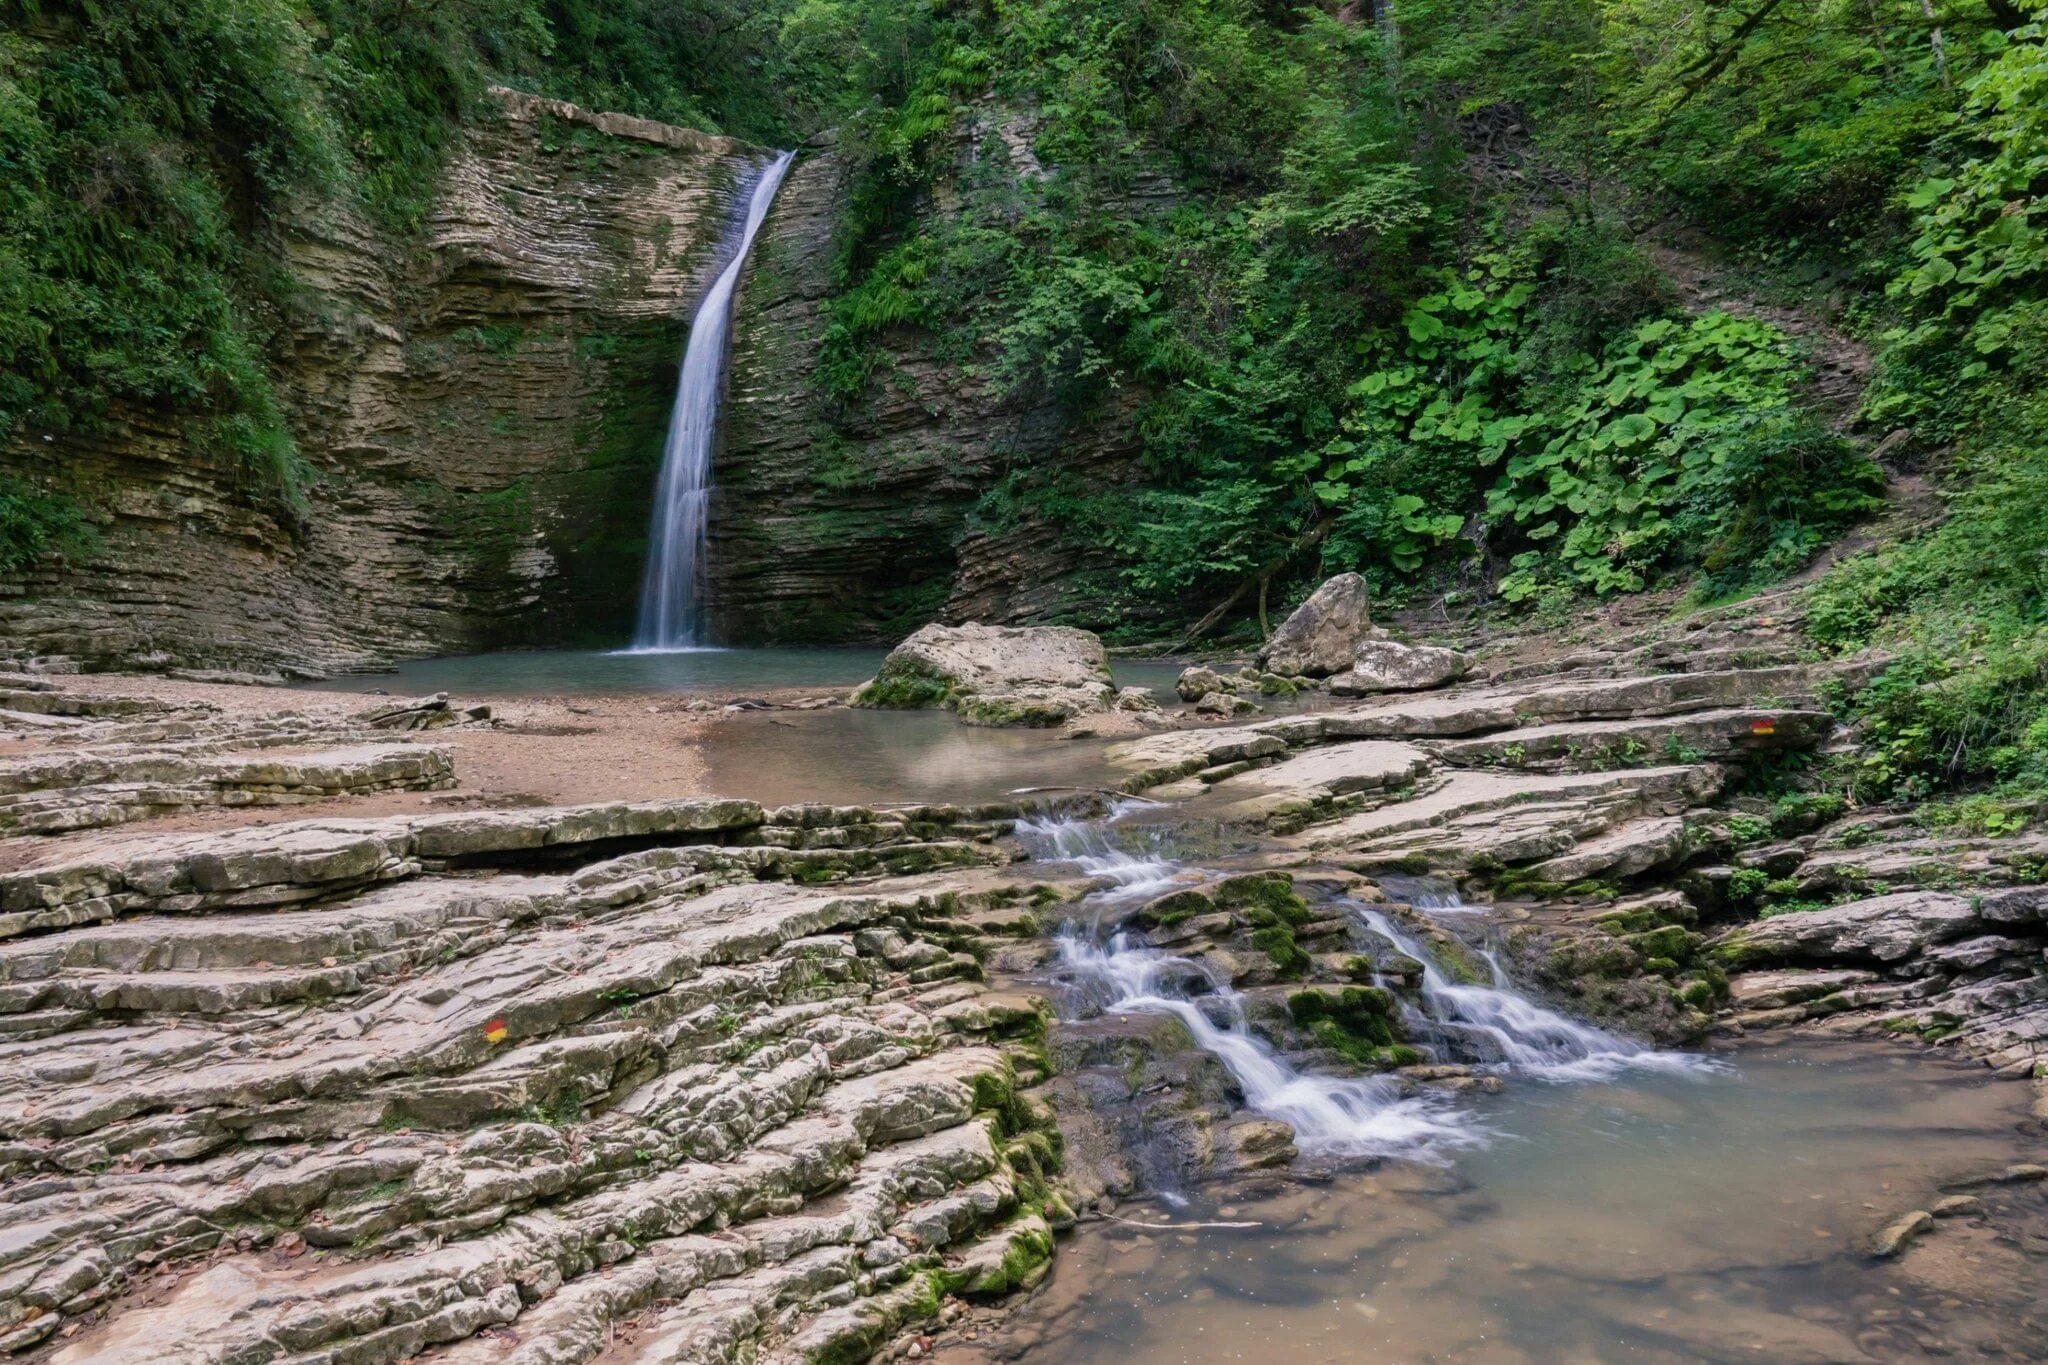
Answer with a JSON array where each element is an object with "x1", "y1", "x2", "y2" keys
[{"x1": 0, "y1": 622, "x2": 2048, "y2": 1363}]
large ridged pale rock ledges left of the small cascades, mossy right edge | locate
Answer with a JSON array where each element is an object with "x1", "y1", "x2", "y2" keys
[{"x1": 0, "y1": 834, "x2": 1051, "y2": 1365}]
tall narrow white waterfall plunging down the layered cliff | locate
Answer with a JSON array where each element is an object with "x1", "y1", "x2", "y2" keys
[{"x1": 633, "y1": 151, "x2": 797, "y2": 651}]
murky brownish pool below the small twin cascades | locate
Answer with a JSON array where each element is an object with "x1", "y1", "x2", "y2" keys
[{"x1": 958, "y1": 1042, "x2": 2048, "y2": 1365}]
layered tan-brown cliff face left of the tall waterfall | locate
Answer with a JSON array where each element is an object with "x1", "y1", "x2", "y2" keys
[{"x1": 0, "y1": 92, "x2": 762, "y2": 669}]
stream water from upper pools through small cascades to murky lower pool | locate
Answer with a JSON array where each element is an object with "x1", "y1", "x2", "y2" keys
[{"x1": 307, "y1": 651, "x2": 2048, "y2": 1365}]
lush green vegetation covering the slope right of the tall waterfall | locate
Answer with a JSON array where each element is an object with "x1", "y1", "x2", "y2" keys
[{"x1": 794, "y1": 0, "x2": 2048, "y2": 798}]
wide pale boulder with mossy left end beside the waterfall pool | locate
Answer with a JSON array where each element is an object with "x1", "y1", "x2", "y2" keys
[{"x1": 852, "y1": 624, "x2": 1116, "y2": 726}]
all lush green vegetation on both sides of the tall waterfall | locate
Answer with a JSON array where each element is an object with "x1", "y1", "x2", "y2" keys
[{"x1": 0, "y1": 0, "x2": 2048, "y2": 810}]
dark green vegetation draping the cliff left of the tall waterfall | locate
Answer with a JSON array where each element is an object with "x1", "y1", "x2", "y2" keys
[{"x1": 0, "y1": 0, "x2": 888, "y2": 532}]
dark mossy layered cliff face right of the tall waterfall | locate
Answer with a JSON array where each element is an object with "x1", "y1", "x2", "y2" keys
[{"x1": 711, "y1": 111, "x2": 1171, "y2": 643}]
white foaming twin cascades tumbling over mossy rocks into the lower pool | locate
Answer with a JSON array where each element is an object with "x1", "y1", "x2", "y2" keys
[{"x1": 1018, "y1": 810, "x2": 1710, "y2": 1160}]
